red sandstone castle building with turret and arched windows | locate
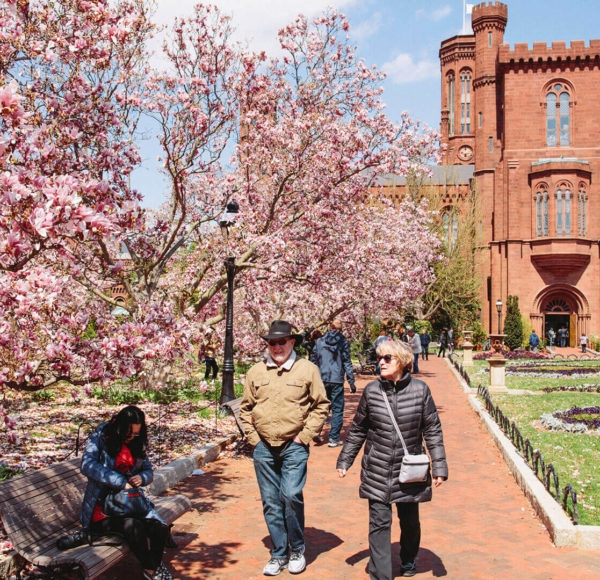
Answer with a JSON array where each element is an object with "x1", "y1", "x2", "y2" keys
[{"x1": 440, "y1": 2, "x2": 600, "y2": 346}]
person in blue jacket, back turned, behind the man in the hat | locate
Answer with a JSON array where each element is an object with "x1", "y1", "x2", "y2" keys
[{"x1": 310, "y1": 320, "x2": 356, "y2": 447}]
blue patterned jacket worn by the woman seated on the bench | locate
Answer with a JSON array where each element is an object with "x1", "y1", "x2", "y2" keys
[{"x1": 80, "y1": 421, "x2": 165, "y2": 530}]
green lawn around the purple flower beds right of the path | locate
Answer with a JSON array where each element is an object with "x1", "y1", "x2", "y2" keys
[{"x1": 458, "y1": 361, "x2": 600, "y2": 525}]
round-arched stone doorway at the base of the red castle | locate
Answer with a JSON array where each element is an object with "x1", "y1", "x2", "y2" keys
[{"x1": 531, "y1": 284, "x2": 590, "y2": 347}]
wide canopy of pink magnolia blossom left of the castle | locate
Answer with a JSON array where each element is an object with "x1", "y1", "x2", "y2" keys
[{"x1": 0, "y1": 0, "x2": 437, "y2": 390}]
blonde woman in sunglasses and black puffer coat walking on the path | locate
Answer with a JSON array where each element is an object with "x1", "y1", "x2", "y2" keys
[{"x1": 336, "y1": 341, "x2": 448, "y2": 580}]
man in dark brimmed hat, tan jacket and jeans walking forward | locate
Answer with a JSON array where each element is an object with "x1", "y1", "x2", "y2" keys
[{"x1": 240, "y1": 320, "x2": 329, "y2": 576}]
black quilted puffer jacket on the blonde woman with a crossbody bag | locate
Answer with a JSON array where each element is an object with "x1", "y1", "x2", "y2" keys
[{"x1": 337, "y1": 372, "x2": 448, "y2": 503}]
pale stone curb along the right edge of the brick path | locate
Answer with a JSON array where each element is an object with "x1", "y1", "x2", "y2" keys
[{"x1": 447, "y1": 360, "x2": 600, "y2": 550}]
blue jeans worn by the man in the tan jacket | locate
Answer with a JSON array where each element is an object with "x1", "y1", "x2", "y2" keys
[{"x1": 253, "y1": 441, "x2": 308, "y2": 559}]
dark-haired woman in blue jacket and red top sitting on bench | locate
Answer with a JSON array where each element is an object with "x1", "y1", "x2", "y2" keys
[{"x1": 59, "y1": 405, "x2": 172, "y2": 580}]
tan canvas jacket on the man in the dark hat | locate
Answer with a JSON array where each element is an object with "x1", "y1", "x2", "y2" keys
[{"x1": 240, "y1": 358, "x2": 329, "y2": 446}]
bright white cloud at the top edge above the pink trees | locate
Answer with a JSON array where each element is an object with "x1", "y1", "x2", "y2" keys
[{"x1": 154, "y1": 0, "x2": 357, "y2": 55}]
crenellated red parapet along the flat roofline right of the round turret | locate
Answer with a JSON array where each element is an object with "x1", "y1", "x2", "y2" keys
[{"x1": 498, "y1": 39, "x2": 600, "y2": 64}]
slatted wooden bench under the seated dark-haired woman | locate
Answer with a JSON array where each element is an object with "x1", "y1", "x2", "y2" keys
[{"x1": 0, "y1": 457, "x2": 191, "y2": 578}]
